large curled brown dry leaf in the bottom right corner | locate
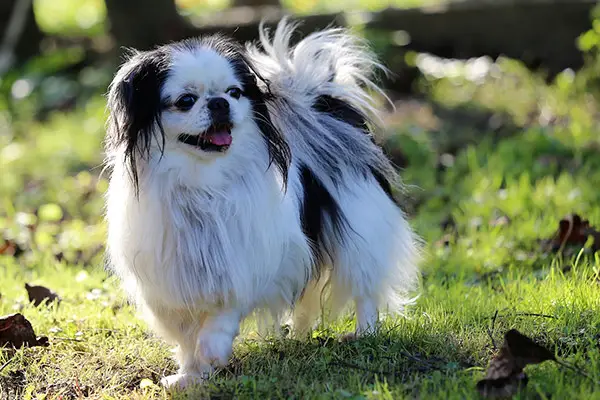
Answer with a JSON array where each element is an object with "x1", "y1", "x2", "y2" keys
[{"x1": 477, "y1": 329, "x2": 556, "y2": 398}]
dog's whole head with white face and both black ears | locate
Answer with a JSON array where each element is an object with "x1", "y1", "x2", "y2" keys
[{"x1": 107, "y1": 36, "x2": 290, "y2": 191}]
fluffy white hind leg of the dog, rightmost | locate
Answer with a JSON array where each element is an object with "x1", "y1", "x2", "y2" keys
[{"x1": 328, "y1": 179, "x2": 418, "y2": 335}]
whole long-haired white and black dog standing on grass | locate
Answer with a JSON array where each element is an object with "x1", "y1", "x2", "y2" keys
[{"x1": 106, "y1": 21, "x2": 419, "y2": 386}]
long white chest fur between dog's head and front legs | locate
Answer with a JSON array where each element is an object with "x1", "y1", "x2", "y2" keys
[{"x1": 108, "y1": 159, "x2": 311, "y2": 308}]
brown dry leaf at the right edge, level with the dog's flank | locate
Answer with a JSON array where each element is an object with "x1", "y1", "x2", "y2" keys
[{"x1": 545, "y1": 214, "x2": 600, "y2": 251}]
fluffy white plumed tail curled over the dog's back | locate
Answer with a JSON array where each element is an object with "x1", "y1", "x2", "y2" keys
[{"x1": 248, "y1": 18, "x2": 388, "y2": 120}]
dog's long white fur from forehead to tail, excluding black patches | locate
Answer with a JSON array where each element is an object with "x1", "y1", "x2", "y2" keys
[{"x1": 106, "y1": 18, "x2": 418, "y2": 385}]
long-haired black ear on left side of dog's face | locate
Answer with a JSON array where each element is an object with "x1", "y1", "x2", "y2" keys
[{"x1": 106, "y1": 49, "x2": 169, "y2": 189}]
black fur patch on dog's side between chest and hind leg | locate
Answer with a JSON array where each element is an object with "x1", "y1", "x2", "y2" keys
[{"x1": 300, "y1": 165, "x2": 344, "y2": 263}]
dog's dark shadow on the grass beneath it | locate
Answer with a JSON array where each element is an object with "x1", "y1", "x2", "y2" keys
[{"x1": 173, "y1": 331, "x2": 473, "y2": 399}]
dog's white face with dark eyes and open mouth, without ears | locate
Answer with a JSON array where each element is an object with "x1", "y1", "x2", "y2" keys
[{"x1": 161, "y1": 48, "x2": 253, "y2": 159}]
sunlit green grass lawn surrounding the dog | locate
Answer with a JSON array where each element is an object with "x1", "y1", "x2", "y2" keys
[{"x1": 0, "y1": 3, "x2": 600, "y2": 399}]
